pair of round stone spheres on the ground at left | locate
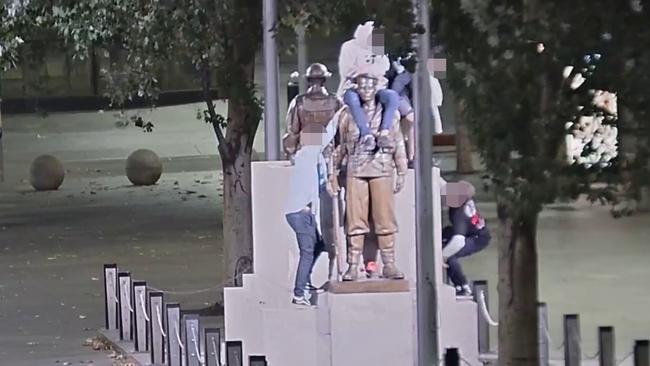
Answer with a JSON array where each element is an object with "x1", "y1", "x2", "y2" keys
[{"x1": 29, "y1": 149, "x2": 163, "y2": 191}]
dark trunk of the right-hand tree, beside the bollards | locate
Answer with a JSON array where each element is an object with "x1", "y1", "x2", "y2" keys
[{"x1": 498, "y1": 206, "x2": 539, "y2": 366}]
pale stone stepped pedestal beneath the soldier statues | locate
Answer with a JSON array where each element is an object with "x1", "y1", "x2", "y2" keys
[{"x1": 224, "y1": 162, "x2": 481, "y2": 366}]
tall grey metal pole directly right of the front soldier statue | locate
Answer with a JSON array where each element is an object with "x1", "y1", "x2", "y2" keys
[{"x1": 413, "y1": 0, "x2": 441, "y2": 366}]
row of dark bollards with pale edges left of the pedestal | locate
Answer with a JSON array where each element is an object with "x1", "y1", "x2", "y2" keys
[{"x1": 104, "y1": 264, "x2": 267, "y2": 366}]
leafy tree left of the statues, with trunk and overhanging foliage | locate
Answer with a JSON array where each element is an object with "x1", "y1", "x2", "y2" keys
[{"x1": 0, "y1": 0, "x2": 412, "y2": 284}]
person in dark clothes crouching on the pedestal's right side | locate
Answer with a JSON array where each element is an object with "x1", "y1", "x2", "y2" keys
[{"x1": 442, "y1": 181, "x2": 491, "y2": 296}]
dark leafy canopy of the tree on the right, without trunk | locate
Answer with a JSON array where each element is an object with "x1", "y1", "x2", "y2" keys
[{"x1": 434, "y1": 0, "x2": 650, "y2": 214}]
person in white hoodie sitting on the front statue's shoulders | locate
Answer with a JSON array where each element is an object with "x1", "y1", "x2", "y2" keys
[{"x1": 337, "y1": 21, "x2": 400, "y2": 151}]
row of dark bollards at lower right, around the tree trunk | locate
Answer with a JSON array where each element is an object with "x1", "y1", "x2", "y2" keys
[{"x1": 468, "y1": 281, "x2": 650, "y2": 366}]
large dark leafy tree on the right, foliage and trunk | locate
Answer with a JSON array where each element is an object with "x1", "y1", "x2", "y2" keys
[{"x1": 434, "y1": 0, "x2": 650, "y2": 365}]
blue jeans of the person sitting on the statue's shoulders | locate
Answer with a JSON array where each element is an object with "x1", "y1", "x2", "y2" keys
[{"x1": 343, "y1": 89, "x2": 400, "y2": 136}]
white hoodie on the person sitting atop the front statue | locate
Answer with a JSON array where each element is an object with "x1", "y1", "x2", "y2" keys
[{"x1": 336, "y1": 21, "x2": 390, "y2": 97}]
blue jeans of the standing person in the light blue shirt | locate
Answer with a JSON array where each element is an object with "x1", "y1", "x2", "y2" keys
[{"x1": 286, "y1": 211, "x2": 325, "y2": 296}]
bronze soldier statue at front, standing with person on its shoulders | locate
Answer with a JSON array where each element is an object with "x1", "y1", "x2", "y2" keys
[{"x1": 328, "y1": 74, "x2": 408, "y2": 281}]
